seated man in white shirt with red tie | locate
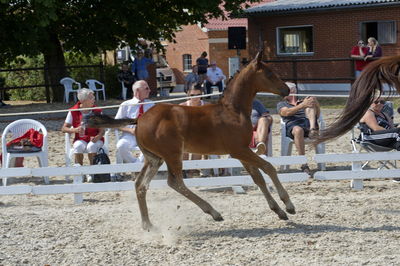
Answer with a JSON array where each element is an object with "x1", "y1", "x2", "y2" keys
[{"x1": 115, "y1": 80, "x2": 154, "y2": 163}]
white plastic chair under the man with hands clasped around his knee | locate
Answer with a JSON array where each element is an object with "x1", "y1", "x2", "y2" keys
[{"x1": 281, "y1": 114, "x2": 326, "y2": 171}]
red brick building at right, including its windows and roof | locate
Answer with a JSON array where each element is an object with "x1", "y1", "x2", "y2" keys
[{"x1": 245, "y1": 0, "x2": 400, "y2": 92}]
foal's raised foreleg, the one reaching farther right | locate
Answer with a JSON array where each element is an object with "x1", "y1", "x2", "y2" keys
[{"x1": 231, "y1": 148, "x2": 296, "y2": 214}]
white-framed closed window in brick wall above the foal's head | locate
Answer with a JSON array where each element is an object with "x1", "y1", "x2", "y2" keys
[{"x1": 276, "y1": 26, "x2": 314, "y2": 55}]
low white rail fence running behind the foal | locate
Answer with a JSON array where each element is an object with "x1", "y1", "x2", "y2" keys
[{"x1": 0, "y1": 152, "x2": 400, "y2": 203}]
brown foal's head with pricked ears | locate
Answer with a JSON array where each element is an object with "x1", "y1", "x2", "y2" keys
[{"x1": 246, "y1": 51, "x2": 289, "y2": 96}]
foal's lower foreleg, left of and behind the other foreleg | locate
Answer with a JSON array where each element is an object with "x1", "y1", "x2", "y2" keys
[{"x1": 241, "y1": 161, "x2": 288, "y2": 220}]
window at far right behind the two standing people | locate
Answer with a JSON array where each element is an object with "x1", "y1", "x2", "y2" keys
[{"x1": 361, "y1": 21, "x2": 397, "y2": 44}]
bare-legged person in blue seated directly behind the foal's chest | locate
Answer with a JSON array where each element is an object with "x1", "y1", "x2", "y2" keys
[{"x1": 250, "y1": 99, "x2": 272, "y2": 155}]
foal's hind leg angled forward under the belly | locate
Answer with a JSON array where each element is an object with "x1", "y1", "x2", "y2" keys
[{"x1": 165, "y1": 157, "x2": 224, "y2": 221}]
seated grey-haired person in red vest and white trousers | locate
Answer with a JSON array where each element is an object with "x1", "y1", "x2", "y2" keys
[{"x1": 61, "y1": 88, "x2": 104, "y2": 165}]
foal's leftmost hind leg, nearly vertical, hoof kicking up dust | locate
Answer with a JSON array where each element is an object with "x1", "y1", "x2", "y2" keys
[{"x1": 135, "y1": 150, "x2": 163, "y2": 230}]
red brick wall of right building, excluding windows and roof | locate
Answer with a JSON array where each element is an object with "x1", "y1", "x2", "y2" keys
[{"x1": 248, "y1": 7, "x2": 400, "y2": 82}]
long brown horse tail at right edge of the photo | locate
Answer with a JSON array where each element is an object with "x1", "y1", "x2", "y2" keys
[{"x1": 315, "y1": 56, "x2": 400, "y2": 143}]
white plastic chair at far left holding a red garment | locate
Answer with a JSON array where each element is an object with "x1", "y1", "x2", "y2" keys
[{"x1": 1, "y1": 119, "x2": 49, "y2": 186}]
